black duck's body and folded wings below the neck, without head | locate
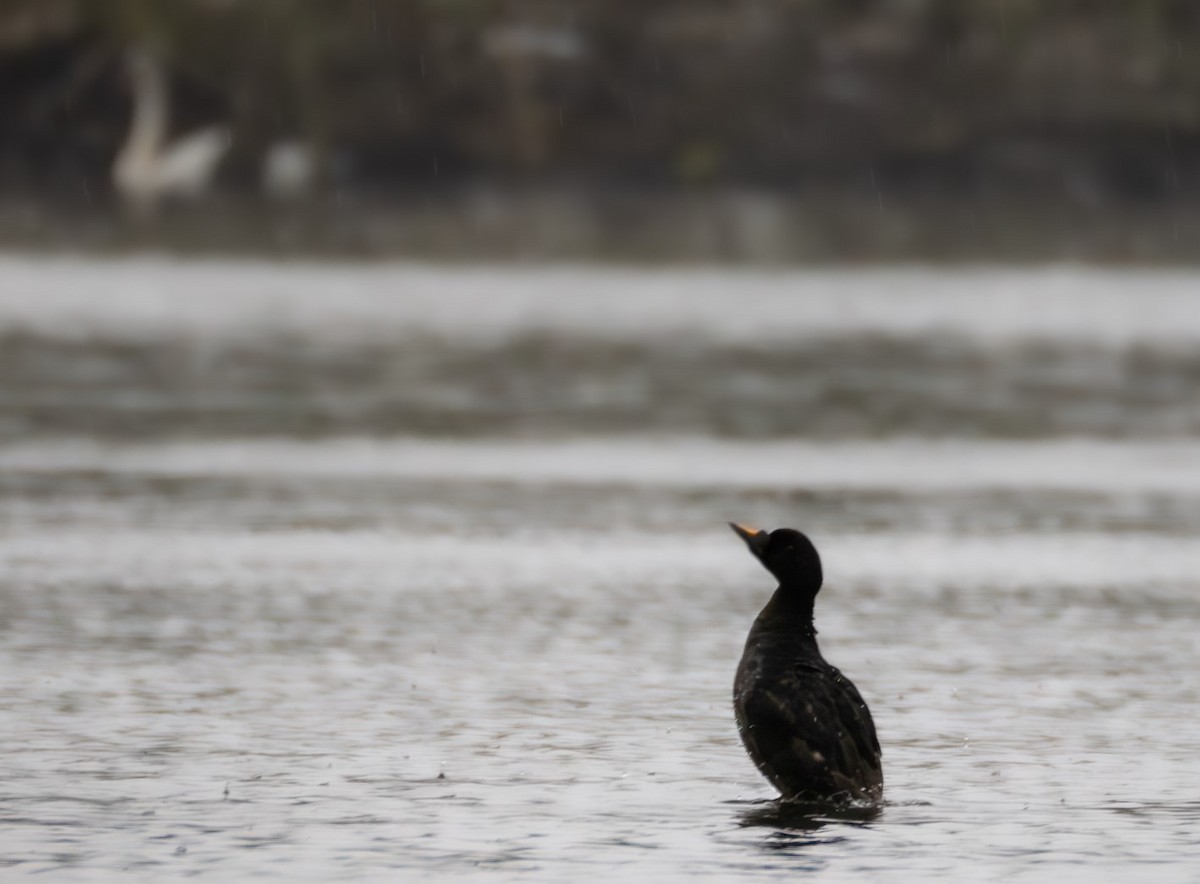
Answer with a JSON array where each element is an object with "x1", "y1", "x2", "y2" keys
[{"x1": 733, "y1": 629, "x2": 883, "y2": 799}]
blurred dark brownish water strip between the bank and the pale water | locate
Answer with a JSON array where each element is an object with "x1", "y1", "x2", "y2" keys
[{"x1": 0, "y1": 187, "x2": 1200, "y2": 266}]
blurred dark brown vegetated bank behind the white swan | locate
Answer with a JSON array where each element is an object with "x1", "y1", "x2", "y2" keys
[{"x1": 0, "y1": 0, "x2": 1200, "y2": 259}]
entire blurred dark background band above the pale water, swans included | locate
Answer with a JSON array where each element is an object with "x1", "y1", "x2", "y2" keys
[{"x1": 7, "y1": 0, "x2": 1200, "y2": 265}]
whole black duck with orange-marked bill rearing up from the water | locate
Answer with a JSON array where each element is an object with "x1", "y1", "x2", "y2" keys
[{"x1": 731, "y1": 523, "x2": 883, "y2": 801}]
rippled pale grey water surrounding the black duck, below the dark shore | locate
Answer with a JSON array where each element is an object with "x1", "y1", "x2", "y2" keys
[{"x1": 0, "y1": 258, "x2": 1200, "y2": 882}]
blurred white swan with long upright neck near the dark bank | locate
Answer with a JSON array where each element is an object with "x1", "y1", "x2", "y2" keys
[{"x1": 113, "y1": 50, "x2": 230, "y2": 215}]
